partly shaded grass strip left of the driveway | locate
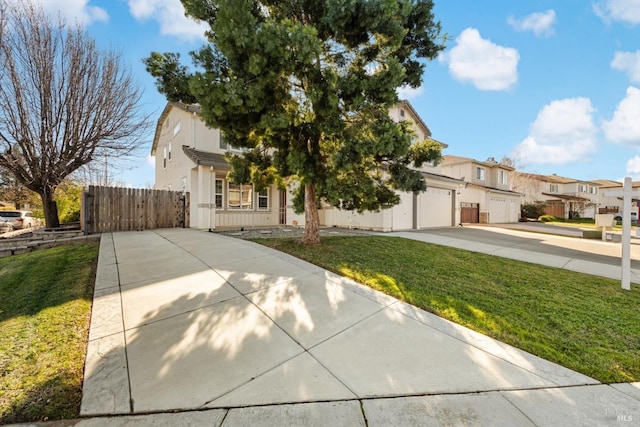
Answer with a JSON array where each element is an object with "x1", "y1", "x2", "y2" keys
[{"x1": 0, "y1": 242, "x2": 98, "y2": 424}]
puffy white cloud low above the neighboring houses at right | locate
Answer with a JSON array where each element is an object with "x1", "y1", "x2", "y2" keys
[{"x1": 514, "y1": 98, "x2": 598, "y2": 165}]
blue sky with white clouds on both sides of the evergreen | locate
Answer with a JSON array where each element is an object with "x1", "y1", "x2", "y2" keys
[{"x1": 36, "y1": 0, "x2": 640, "y2": 187}]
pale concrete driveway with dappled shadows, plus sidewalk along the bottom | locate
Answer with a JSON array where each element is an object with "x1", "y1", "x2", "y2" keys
[{"x1": 11, "y1": 229, "x2": 640, "y2": 427}]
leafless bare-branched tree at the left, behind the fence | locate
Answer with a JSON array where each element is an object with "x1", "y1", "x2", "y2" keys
[{"x1": 0, "y1": 1, "x2": 149, "y2": 227}]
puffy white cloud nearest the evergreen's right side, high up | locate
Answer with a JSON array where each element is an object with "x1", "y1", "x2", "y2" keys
[{"x1": 439, "y1": 28, "x2": 520, "y2": 90}]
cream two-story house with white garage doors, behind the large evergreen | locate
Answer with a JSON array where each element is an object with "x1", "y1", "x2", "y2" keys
[{"x1": 151, "y1": 101, "x2": 465, "y2": 231}]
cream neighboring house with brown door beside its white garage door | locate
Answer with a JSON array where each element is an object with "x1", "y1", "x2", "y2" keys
[{"x1": 442, "y1": 155, "x2": 522, "y2": 224}]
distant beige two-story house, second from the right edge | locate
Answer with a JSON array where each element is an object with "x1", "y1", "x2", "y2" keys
[{"x1": 512, "y1": 172, "x2": 600, "y2": 218}]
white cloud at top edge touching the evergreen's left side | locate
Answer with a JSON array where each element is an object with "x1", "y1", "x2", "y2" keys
[{"x1": 127, "y1": 0, "x2": 209, "y2": 40}]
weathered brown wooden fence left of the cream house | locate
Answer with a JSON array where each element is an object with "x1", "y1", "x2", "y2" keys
[{"x1": 80, "y1": 185, "x2": 189, "y2": 234}]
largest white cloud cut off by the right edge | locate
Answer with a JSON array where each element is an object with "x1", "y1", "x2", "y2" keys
[{"x1": 602, "y1": 86, "x2": 640, "y2": 146}]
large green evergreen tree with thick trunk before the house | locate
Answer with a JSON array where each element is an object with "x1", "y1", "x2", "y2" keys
[{"x1": 144, "y1": 0, "x2": 444, "y2": 243}]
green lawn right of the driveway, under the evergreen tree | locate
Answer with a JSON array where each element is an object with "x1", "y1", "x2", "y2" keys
[{"x1": 259, "y1": 236, "x2": 640, "y2": 383}]
